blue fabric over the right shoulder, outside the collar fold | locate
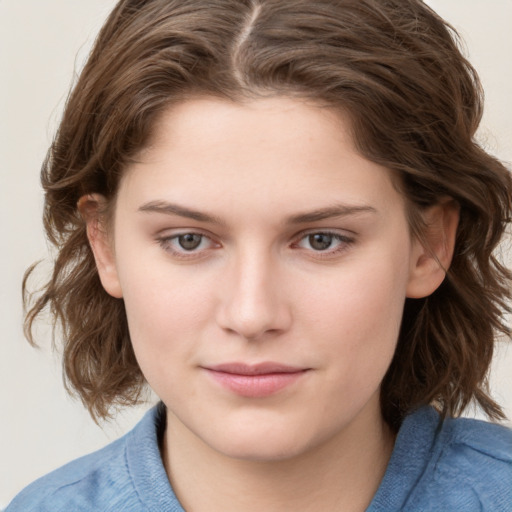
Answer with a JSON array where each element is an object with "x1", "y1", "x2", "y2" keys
[{"x1": 417, "y1": 408, "x2": 512, "y2": 511}]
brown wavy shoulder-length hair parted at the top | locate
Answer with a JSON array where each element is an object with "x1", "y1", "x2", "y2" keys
[{"x1": 24, "y1": 0, "x2": 512, "y2": 428}]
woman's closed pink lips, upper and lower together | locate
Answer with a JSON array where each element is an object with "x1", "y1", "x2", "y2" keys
[{"x1": 202, "y1": 362, "x2": 310, "y2": 398}]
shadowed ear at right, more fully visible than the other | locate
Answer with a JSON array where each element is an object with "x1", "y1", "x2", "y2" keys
[{"x1": 407, "y1": 199, "x2": 460, "y2": 299}]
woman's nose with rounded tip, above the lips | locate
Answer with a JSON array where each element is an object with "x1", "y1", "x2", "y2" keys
[{"x1": 217, "y1": 251, "x2": 292, "y2": 340}]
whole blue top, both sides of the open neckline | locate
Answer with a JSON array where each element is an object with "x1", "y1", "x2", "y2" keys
[{"x1": 6, "y1": 406, "x2": 512, "y2": 512}]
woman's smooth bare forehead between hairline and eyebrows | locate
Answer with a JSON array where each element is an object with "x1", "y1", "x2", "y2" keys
[{"x1": 120, "y1": 97, "x2": 400, "y2": 223}]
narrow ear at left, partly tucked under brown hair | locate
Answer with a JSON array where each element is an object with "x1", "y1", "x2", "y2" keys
[{"x1": 77, "y1": 194, "x2": 123, "y2": 299}]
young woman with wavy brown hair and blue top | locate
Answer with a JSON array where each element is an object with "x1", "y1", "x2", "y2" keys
[{"x1": 8, "y1": 0, "x2": 512, "y2": 511}]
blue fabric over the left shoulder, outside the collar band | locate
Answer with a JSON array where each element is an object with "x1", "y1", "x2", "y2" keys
[{"x1": 6, "y1": 410, "x2": 166, "y2": 512}]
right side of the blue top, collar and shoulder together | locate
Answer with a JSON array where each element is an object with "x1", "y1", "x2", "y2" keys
[{"x1": 367, "y1": 407, "x2": 512, "y2": 512}]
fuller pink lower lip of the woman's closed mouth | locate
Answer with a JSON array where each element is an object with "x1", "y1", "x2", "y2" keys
[{"x1": 207, "y1": 370, "x2": 307, "y2": 398}]
